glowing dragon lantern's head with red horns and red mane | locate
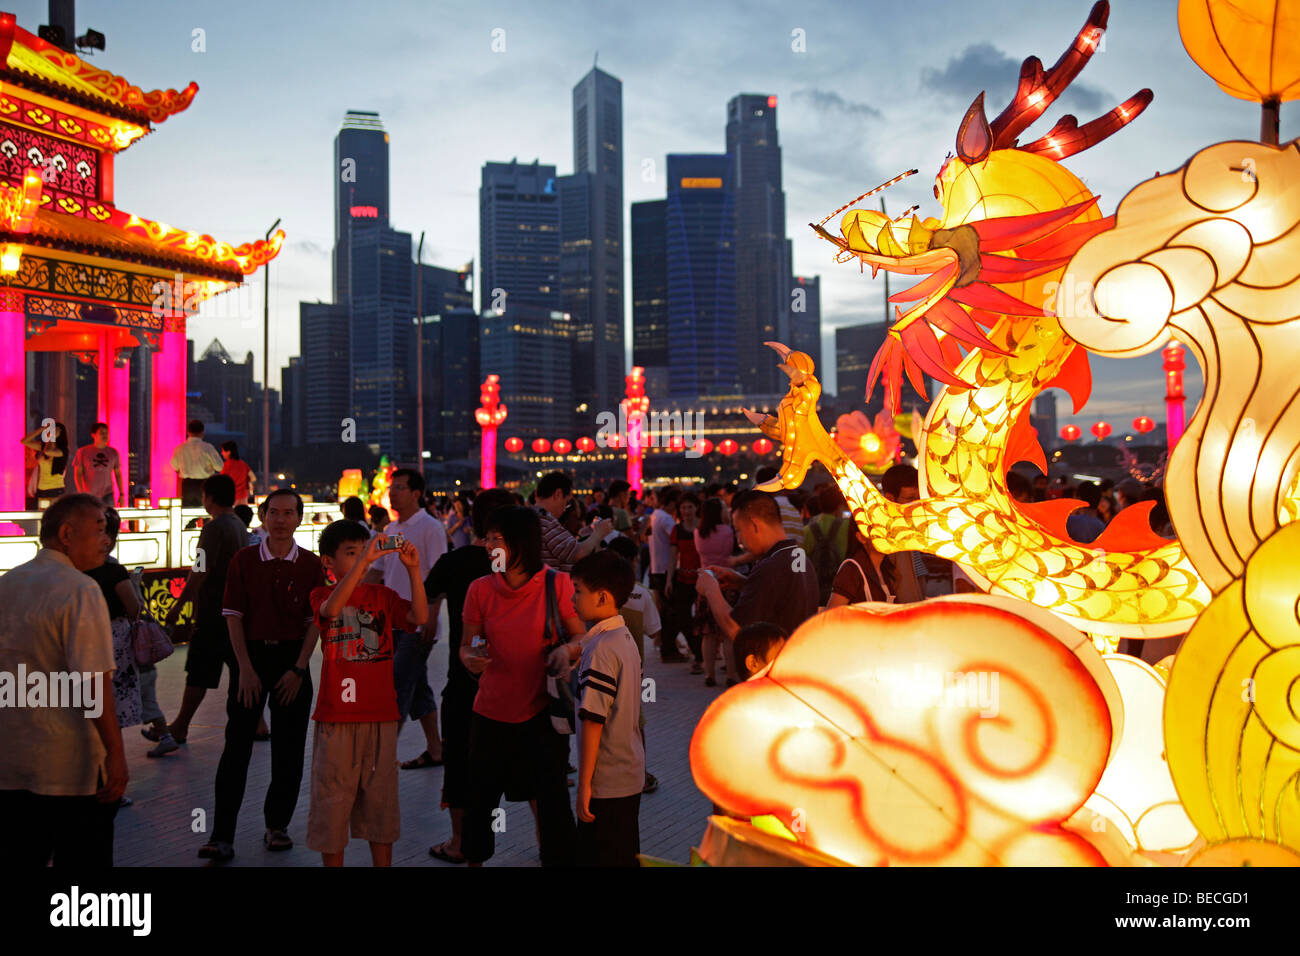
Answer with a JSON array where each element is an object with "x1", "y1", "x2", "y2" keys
[{"x1": 810, "y1": 0, "x2": 1152, "y2": 412}]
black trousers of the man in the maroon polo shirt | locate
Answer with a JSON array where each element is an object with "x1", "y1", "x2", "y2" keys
[{"x1": 212, "y1": 641, "x2": 312, "y2": 843}]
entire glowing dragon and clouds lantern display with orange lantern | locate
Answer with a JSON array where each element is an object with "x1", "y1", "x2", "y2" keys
[{"x1": 690, "y1": 0, "x2": 1300, "y2": 866}]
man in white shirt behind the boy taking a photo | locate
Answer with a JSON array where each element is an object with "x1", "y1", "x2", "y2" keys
[{"x1": 367, "y1": 468, "x2": 447, "y2": 770}]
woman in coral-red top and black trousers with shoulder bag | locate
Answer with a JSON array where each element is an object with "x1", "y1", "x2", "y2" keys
[{"x1": 460, "y1": 507, "x2": 586, "y2": 866}]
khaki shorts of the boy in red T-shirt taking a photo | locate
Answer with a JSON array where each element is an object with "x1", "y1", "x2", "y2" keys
[{"x1": 307, "y1": 721, "x2": 400, "y2": 853}]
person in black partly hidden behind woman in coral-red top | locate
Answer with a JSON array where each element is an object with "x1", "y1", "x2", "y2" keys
[{"x1": 424, "y1": 488, "x2": 515, "y2": 864}]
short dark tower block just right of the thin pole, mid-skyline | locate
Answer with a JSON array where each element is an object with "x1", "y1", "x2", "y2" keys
[{"x1": 425, "y1": 308, "x2": 483, "y2": 459}]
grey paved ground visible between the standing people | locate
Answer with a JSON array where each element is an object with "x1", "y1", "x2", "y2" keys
[{"x1": 114, "y1": 610, "x2": 722, "y2": 866}]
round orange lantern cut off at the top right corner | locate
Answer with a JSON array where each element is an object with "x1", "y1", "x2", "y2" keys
[{"x1": 1178, "y1": 0, "x2": 1300, "y2": 103}]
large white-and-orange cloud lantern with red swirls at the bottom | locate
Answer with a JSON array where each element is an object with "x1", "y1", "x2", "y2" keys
[{"x1": 690, "y1": 596, "x2": 1122, "y2": 865}]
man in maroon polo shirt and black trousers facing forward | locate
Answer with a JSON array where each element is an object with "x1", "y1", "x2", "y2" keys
[{"x1": 199, "y1": 488, "x2": 325, "y2": 862}]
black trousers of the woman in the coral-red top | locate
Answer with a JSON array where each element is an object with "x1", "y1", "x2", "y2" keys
[{"x1": 460, "y1": 710, "x2": 575, "y2": 866}]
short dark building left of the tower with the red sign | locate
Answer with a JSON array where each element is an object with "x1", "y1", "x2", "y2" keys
[{"x1": 298, "y1": 302, "x2": 354, "y2": 445}]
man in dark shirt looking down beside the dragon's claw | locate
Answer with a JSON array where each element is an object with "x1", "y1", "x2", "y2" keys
[{"x1": 696, "y1": 490, "x2": 819, "y2": 640}]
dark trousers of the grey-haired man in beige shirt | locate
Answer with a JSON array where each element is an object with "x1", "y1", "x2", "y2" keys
[{"x1": 0, "y1": 790, "x2": 117, "y2": 870}]
